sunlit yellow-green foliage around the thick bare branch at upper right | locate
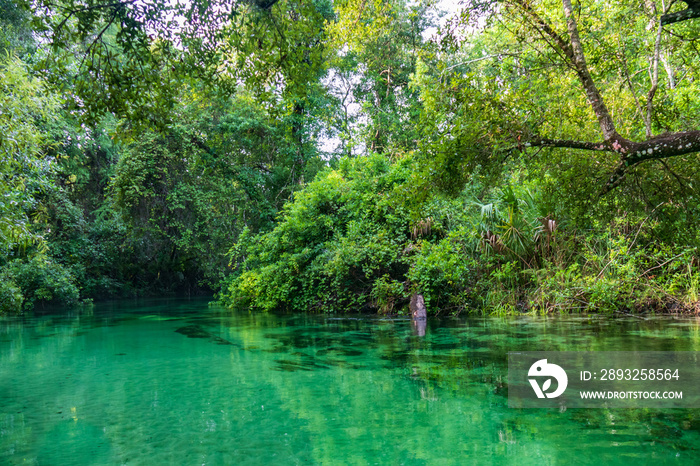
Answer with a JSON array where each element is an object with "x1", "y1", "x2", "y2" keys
[{"x1": 413, "y1": 0, "x2": 700, "y2": 222}]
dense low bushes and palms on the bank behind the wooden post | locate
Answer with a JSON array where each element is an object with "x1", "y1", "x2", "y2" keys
[{"x1": 219, "y1": 156, "x2": 700, "y2": 315}]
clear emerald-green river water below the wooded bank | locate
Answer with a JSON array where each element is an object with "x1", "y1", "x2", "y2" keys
[{"x1": 0, "y1": 300, "x2": 700, "y2": 465}]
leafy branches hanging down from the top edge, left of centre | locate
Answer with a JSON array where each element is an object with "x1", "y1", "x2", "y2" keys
[{"x1": 30, "y1": 0, "x2": 331, "y2": 126}]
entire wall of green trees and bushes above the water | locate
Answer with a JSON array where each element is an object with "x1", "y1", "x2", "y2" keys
[{"x1": 0, "y1": 0, "x2": 700, "y2": 314}]
